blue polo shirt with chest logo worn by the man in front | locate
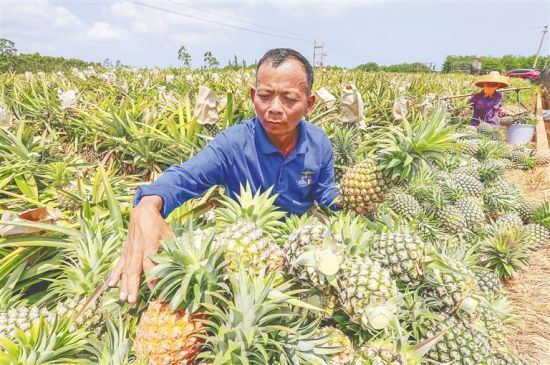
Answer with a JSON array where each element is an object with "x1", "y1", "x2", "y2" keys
[{"x1": 134, "y1": 118, "x2": 339, "y2": 218}]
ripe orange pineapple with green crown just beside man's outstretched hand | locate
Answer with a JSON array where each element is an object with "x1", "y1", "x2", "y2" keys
[{"x1": 139, "y1": 228, "x2": 226, "y2": 365}]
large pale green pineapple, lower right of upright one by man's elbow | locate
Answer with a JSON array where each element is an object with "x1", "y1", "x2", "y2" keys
[{"x1": 371, "y1": 233, "x2": 426, "y2": 284}]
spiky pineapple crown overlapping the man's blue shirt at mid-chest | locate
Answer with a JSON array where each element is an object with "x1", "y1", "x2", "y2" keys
[{"x1": 216, "y1": 182, "x2": 285, "y2": 234}]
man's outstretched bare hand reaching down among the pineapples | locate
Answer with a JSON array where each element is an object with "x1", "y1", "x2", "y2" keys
[{"x1": 108, "y1": 195, "x2": 173, "y2": 304}]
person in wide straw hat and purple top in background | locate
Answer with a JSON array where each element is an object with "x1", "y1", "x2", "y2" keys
[{"x1": 469, "y1": 71, "x2": 508, "y2": 126}]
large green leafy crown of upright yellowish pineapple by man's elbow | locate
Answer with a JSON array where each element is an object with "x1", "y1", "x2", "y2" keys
[{"x1": 378, "y1": 109, "x2": 462, "y2": 181}]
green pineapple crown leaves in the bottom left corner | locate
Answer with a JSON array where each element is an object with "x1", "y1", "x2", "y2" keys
[{"x1": 0, "y1": 318, "x2": 88, "y2": 365}]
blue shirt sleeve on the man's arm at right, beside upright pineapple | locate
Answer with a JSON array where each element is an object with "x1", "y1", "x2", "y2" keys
[{"x1": 315, "y1": 135, "x2": 340, "y2": 210}]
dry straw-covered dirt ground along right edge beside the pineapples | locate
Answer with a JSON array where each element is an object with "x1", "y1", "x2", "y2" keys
[{"x1": 505, "y1": 167, "x2": 550, "y2": 365}]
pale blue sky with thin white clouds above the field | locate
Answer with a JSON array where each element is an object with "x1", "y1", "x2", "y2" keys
[{"x1": 0, "y1": 0, "x2": 550, "y2": 68}]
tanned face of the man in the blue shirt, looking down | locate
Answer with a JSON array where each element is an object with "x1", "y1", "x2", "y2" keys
[{"x1": 250, "y1": 59, "x2": 315, "y2": 137}]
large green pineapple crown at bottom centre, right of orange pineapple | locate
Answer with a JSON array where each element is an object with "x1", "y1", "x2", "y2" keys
[{"x1": 199, "y1": 268, "x2": 324, "y2": 364}]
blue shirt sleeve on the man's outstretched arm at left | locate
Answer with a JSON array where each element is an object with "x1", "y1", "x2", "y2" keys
[{"x1": 134, "y1": 132, "x2": 231, "y2": 218}]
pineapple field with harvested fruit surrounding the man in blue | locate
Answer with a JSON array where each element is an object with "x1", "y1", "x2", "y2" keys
[{"x1": 0, "y1": 67, "x2": 550, "y2": 365}]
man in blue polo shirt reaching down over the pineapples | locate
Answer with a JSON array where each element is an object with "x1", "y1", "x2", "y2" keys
[{"x1": 109, "y1": 48, "x2": 338, "y2": 303}]
